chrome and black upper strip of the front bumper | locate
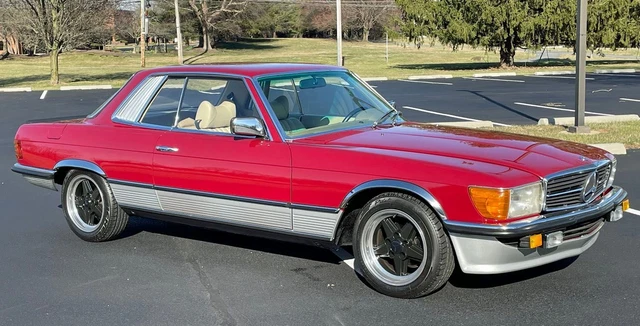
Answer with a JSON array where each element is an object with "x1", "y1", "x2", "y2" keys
[{"x1": 443, "y1": 186, "x2": 627, "y2": 238}]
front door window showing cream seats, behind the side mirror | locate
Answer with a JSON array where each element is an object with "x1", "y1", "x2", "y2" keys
[{"x1": 177, "y1": 77, "x2": 260, "y2": 133}]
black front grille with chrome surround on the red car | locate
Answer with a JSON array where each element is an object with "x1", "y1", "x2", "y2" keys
[{"x1": 543, "y1": 160, "x2": 612, "y2": 212}]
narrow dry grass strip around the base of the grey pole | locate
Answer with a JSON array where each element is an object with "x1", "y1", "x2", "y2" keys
[{"x1": 491, "y1": 121, "x2": 640, "y2": 149}]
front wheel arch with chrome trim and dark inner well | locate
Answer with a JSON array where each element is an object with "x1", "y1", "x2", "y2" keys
[{"x1": 333, "y1": 179, "x2": 447, "y2": 245}]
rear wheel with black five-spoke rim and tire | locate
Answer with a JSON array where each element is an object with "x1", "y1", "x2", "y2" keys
[{"x1": 61, "y1": 170, "x2": 129, "y2": 242}]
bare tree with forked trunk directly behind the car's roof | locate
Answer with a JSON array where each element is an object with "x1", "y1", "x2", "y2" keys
[{"x1": 188, "y1": 0, "x2": 248, "y2": 51}]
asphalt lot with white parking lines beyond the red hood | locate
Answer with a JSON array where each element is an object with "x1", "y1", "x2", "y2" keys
[{"x1": 369, "y1": 73, "x2": 640, "y2": 125}]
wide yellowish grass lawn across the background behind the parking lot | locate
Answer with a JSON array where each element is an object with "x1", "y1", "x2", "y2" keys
[{"x1": 0, "y1": 39, "x2": 640, "y2": 90}]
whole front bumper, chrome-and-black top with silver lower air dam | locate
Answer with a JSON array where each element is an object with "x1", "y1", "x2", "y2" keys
[{"x1": 444, "y1": 186, "x2": 627, "y2": 274}]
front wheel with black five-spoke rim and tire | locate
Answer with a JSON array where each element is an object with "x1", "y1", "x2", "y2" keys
[{"x1": 353, "y1": 192, "x2": 455, "y2": 299}]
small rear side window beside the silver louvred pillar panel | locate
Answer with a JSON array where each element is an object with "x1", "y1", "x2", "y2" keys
[{"x1": 140, "y1": 77, "x2": 185, "y2": 127}]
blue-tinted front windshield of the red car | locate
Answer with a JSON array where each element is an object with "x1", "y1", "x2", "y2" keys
[{"x1": 259, "y1": 71, "x2": 400, "y2": 138}]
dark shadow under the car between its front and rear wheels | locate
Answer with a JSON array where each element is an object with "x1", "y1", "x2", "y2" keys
[{"x1": 119, "y1": 216, "x2": 341, "y2": 265}]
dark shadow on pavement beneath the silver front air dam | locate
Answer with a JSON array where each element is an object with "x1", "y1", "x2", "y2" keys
[{"x1": 449, "y1": 257, "x2": 578, "y2": 289}]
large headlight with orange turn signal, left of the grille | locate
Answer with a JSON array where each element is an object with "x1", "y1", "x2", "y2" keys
[{"x1": 469, "y1": 182, "x2": 544, "y2": 220}]
